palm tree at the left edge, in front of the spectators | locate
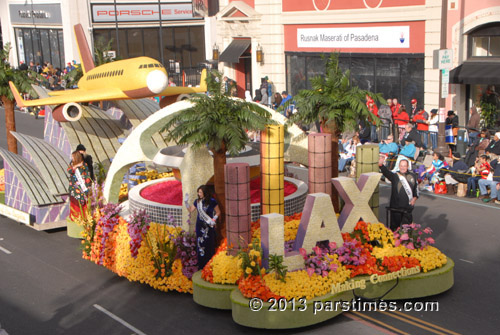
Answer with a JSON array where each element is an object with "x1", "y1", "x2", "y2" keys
[{"x1": 0, "y1": 43, "x2": 36, "y2": 154}]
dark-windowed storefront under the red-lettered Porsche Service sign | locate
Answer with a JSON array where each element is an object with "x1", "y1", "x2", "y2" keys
[{"x1": 91, "y1": 1, "x2": 206, "y2": 84}]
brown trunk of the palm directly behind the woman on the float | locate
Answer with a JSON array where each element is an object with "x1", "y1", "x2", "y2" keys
[{"x1": 213, "y1": 144, "x2": 226, "y2": 245}]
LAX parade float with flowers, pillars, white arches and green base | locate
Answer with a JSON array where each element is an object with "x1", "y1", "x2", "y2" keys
[{"x1": 0, "y1": 24, "x2": 454, "y2": 329}]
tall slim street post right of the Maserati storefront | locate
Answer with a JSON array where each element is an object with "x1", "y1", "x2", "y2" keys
[{"x1": 436, "y1": 0, "x2": 449, "y2": 157}]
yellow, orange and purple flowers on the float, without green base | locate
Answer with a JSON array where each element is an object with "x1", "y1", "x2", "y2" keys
[{"x1": 79, "y1": 204, "x2": 447, "y2": 294}]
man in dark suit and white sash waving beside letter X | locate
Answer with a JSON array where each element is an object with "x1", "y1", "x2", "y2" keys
[{"x1": 378, "y1": 157, "x2": 419, "y2": 231}]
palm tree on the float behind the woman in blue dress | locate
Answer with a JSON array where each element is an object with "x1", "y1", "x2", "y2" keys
[{"x1": 162, "y1": 70, "x2": 274, "y2": 243}]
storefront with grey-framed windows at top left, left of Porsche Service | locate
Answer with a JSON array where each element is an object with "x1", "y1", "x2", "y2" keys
[{"x1": 9, "y1": 3, "x2": 65, "y2": 68}]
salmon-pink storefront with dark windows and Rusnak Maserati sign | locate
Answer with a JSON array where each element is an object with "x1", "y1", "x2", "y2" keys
[{"x1": 283, "y1": 0, "x2": 426, "y2": 107}]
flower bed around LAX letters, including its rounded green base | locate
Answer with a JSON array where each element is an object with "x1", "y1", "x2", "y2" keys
[{"x1": 78, "y1": 188, "x2": 453, "y2": 328}]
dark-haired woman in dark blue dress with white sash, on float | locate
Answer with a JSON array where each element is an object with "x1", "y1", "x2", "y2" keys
[{"x1": 184, "y1": 185, "x2": 220, "y2": 269}]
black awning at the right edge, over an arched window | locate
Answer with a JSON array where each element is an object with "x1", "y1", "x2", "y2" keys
[{"x1": 450, "y1": 60, "x2": 500, "y2": 85}]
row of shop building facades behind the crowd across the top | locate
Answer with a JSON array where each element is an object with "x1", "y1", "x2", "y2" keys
[{"x1": 0, "y1": 0, "x2": 500, "y2": 124}]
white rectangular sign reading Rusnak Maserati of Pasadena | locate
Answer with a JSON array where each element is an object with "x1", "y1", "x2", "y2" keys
[{"x1": 297, "y1": 26, "x2": 410, "y2": 48}]
